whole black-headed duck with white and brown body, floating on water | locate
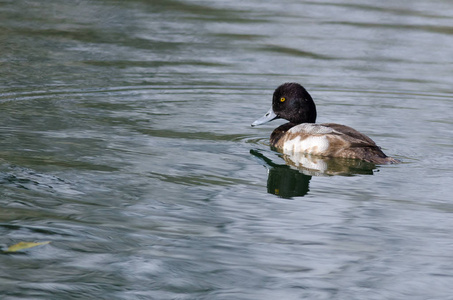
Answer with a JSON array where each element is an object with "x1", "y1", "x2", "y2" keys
[{"x1": 252, "y1": 83, "x2": 399, "y2": 164}]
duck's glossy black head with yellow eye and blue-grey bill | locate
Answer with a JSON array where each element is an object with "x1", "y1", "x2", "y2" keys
[{"x1": 252, "y1": 82, "x2": 316, "y2": 126}]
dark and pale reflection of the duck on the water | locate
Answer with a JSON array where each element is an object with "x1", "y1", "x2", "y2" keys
[{"x1": 250, "y1": 149, "x2": 376, "y2": 198}]
